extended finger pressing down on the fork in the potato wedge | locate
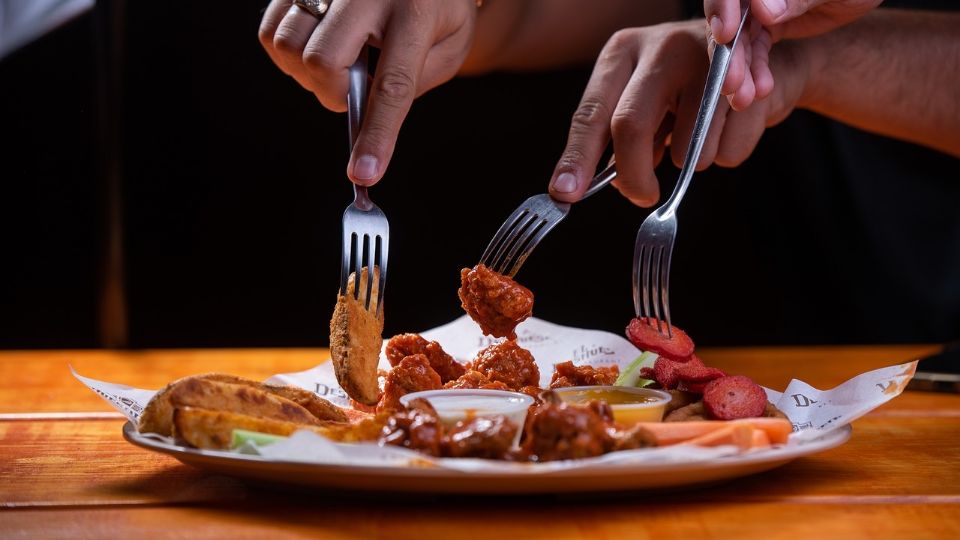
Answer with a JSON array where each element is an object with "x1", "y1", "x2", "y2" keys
[{"x1": 347, "y1": 10, "x2": 432, "y2": 185}]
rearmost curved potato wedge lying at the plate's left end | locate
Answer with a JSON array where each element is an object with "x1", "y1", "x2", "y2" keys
[{"x1": 137, "y1": 373, "x2": 350, "y2": 436}]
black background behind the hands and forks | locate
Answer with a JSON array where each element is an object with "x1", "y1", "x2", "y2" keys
[{"x1": 0, "y1": 1, "x2": 960, "y2": 348}]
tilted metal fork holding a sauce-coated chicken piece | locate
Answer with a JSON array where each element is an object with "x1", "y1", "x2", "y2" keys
[{"x1": 480, "y1": 163, "x2": 617, "y2": 277}]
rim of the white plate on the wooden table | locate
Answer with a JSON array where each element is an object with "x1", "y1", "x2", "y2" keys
[{"x1": 123, "y1": 422, "x2": 851, "y2": 495}]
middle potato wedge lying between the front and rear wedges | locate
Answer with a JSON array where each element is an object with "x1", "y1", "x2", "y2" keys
[{"x1": 170, "y1": 379, "x2": 321, "y2": 426}]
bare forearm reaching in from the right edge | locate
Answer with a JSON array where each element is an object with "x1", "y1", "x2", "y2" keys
[{"x1": 799, "y1": 9, "x2": 960, "y2": 156}]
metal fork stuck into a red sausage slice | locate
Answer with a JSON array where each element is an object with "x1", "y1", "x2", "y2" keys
[{"x1": 633, "y1": 0, "x2": 750, "y2": 337}]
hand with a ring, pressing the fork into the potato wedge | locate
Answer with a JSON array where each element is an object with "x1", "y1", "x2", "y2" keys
[{"x1": 259, "y1": 0, "x2": 477, "y2": 186}]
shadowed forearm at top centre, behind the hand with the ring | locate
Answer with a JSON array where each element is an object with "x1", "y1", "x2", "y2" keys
[{"x1": 461, "y1": 0, "x2": 681, "y2": 74}]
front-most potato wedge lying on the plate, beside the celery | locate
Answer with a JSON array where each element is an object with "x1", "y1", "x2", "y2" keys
[{"x1": 173, "y1": 407, "x2": 387, "y2": 450}]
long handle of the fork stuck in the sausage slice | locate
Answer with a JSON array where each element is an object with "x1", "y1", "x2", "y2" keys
[{"x1": 662, "y1": 0, "x2": 750, "y2": 215}]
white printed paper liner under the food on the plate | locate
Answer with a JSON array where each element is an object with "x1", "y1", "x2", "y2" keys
[{"x1": 71, "y1": 316, "x2": 917, "y2": 473}]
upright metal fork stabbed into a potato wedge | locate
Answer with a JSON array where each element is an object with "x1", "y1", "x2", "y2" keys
[{"x1": 340, "y1": 46, "x2": 390, "y2": 318}]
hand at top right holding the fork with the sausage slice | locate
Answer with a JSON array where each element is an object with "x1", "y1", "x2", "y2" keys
[{"x1": 703, "y1": 0, "x2": 883, "y2": 110}]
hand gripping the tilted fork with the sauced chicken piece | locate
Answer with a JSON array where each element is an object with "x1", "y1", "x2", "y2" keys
[{"x1": 550, "y1": 21, "x2": 810, "y2": 207}]
